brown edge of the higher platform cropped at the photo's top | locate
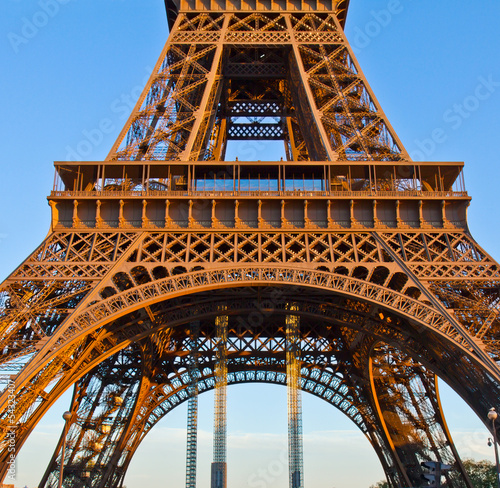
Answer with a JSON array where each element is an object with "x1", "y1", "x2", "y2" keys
[{"x1": 165, "y1": 0, "x2": 350, "y2": 29}]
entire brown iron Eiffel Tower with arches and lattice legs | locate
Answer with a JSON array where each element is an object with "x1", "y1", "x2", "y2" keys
[{"x1": 0, "y1": 0, "x2": 500, "y2": 488}]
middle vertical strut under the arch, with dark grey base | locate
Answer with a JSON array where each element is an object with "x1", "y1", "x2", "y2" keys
[{"x1": 211, "y1": 308, "x2": 228, "y2": 488}]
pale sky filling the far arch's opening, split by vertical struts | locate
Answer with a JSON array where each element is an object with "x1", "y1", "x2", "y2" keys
[{"x1": 124, "y1": 383, "x2": 385, "y2": 488}]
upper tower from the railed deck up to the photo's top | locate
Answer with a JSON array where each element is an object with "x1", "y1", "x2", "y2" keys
[{"x1": 47, "y1": 0, "x2": 468, "y2": 233}]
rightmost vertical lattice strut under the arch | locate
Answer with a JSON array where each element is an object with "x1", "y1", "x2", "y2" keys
[{"x1": 286, "y1": 304, "x2": 304, "y2": 488}]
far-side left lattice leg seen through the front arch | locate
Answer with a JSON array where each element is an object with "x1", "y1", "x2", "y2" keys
[{"x1": 40, "y1": 347, "x2": 146, "y2": 487}]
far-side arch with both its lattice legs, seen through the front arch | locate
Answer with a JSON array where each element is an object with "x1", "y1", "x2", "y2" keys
[{"x1": 35, "y1": 304, "x2": 472, "y2": 488}]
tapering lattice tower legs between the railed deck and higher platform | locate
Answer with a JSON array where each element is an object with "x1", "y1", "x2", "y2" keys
[{"x1": 108, "y1": 12, "x2": 409, "y2": 161}]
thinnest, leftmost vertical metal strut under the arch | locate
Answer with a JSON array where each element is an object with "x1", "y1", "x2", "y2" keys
[{"x1": 186, "y1": 322, "x2": 200, "y2": 488}]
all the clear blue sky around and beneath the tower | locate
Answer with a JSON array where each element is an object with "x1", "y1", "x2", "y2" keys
[{"x1": 0, "y1": 0, "x2": 500, "y2": 488}]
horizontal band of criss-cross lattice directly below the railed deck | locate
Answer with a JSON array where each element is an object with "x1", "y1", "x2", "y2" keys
[{"x1": 2, "y1": 230, "x2": 500, "y2": 284}]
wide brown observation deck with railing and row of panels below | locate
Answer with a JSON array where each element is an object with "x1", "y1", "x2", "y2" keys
[{"x1": 49, "y1": 161, "x2": 470, "y2": 230}]
